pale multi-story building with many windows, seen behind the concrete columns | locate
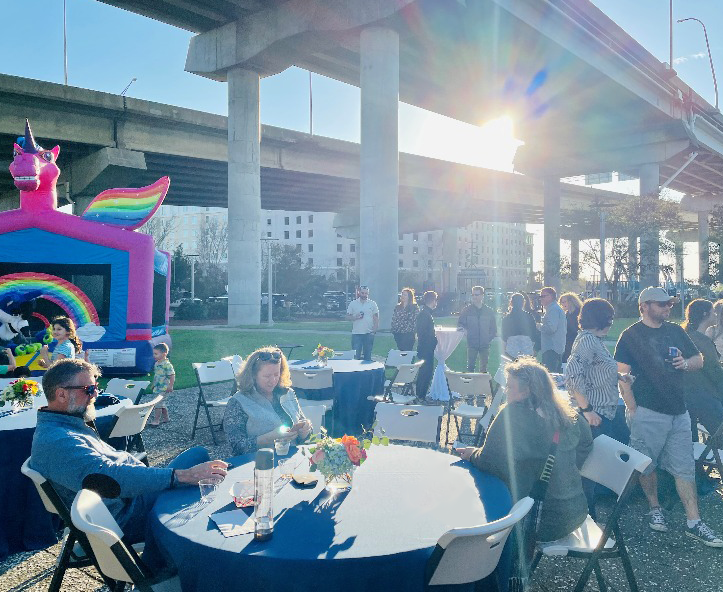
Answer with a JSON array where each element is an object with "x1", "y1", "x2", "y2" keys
[{"x1": 157, "y1": 206, "x2": 532, "y2": 292}]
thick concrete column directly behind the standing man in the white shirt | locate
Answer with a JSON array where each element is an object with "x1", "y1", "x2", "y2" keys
[{"x1": 359, "y1": 27, "x2": 399, "y2": 329}]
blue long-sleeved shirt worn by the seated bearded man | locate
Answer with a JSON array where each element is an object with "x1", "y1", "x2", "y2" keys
[{"x1": 30, "y1": 408, "x2": 172, "y2": 528}]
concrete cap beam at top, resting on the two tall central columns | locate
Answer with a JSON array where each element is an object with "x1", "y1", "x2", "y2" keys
[{"x1": 186, "y1": 0, "x2": 414, "y2": 80}]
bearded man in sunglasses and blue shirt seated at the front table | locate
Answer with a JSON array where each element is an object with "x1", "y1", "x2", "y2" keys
[{"x1": 30, "y1": 359, "x2": 228, "y2": 543}]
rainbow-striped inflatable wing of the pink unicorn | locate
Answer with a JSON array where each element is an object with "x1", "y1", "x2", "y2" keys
[{"x1": 81, "y1": 177, "x2": 171, "y2": 230}]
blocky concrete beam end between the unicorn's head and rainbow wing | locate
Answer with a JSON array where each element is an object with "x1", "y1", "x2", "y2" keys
[{"x1": 70, "y1": 147, "x2": 146, "y2": 196}]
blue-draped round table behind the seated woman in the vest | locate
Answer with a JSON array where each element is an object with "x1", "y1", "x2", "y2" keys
[{"x1": 289, "y1": 360, "x2": 384, "y2": 435}]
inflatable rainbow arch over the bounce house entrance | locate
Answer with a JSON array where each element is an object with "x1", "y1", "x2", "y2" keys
[{"x1": 0, "y1": 272, "x2": 100, "y2": 327}]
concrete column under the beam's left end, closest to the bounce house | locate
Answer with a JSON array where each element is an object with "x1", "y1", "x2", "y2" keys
[{"x1": 228, "y1": 68, "x2": 261, "y2": 325}]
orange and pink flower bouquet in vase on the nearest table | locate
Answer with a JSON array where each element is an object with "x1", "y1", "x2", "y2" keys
[{"x1": 309, "y1": 428, "x2": 389, "y2": 491}]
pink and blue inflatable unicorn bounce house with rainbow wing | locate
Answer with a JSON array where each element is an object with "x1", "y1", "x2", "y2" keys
[{"x1": 0, "y1": 121, "x2": 171, "y2": 375}]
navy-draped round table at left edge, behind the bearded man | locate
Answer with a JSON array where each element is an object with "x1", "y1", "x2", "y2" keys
[{"x1": 0, "y1": 395, "x2": 132, "y2": 559}]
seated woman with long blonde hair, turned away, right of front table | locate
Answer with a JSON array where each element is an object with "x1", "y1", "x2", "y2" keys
[{"x1": 458, "y1": 358, "x2": 592, "y2": 541}]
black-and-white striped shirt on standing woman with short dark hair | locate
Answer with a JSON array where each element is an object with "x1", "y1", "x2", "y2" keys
[{"x1": 565, "y1": 330, "x2": 619, "y2": 419}]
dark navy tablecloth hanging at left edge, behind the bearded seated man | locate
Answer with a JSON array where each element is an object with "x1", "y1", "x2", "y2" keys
[{"x1": 0, "y1": 398, "x2": 126, "y2": 560}]
